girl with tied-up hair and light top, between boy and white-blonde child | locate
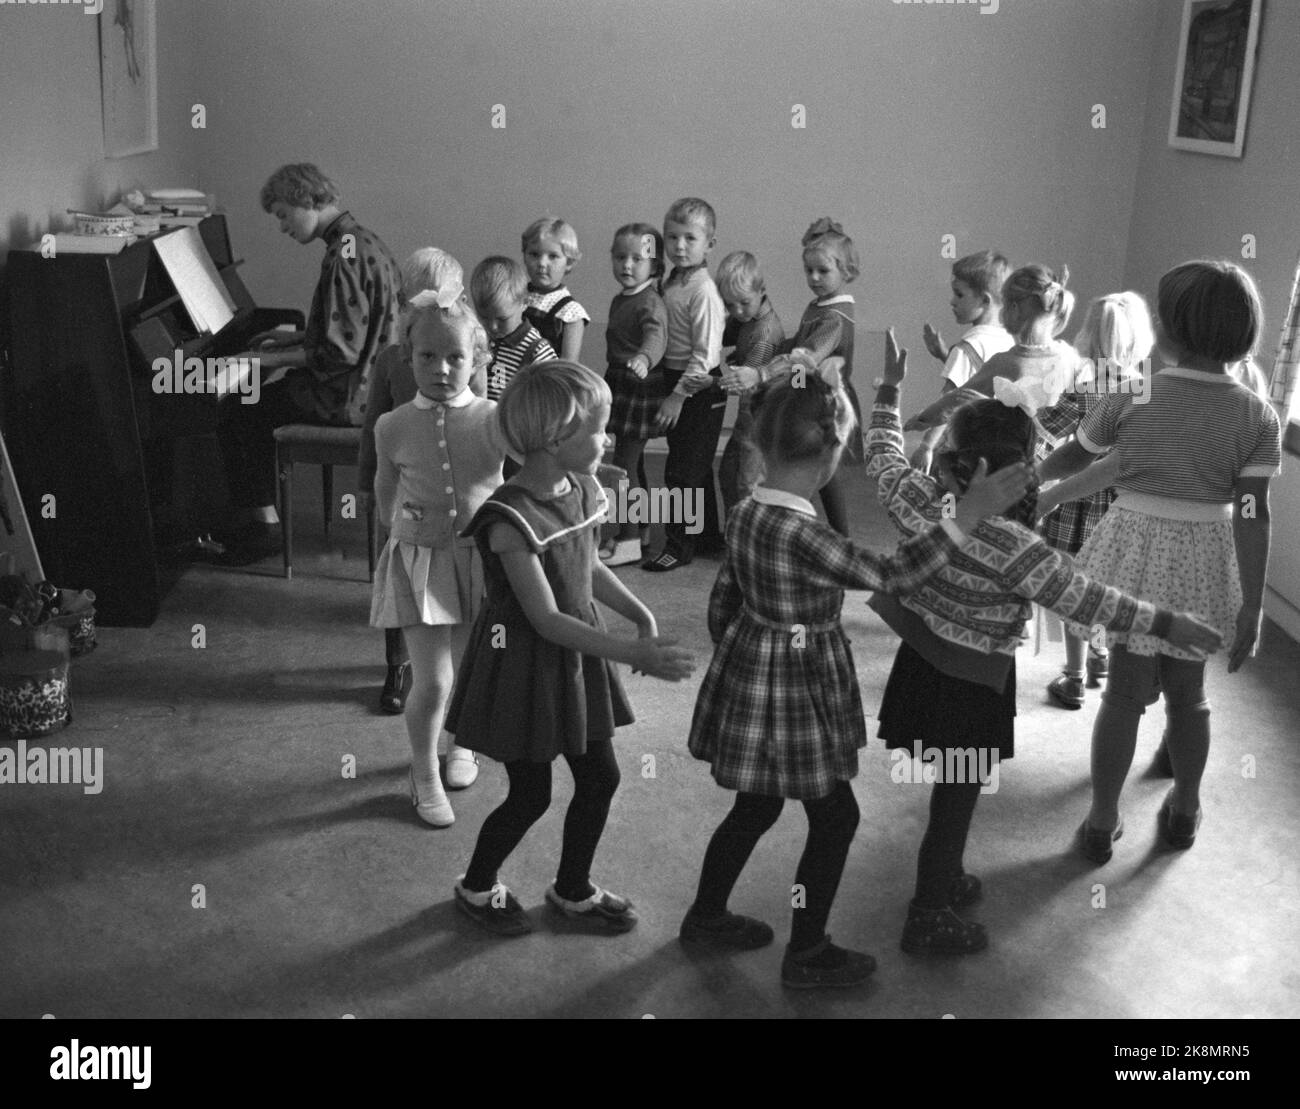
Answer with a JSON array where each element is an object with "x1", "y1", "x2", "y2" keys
[{"x1": 904, "y1": 265, "x2": 1078, "y2": 432}]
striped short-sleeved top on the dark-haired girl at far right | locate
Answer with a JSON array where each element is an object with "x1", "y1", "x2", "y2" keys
[{"x1": 1078, "y1": 367, "x2": 1282, "y2": 504}]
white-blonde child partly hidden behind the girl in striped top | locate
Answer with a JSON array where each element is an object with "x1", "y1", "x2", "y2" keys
[{"x1": 1036, "y1": 293, "x2": 1156, "y2": 709}]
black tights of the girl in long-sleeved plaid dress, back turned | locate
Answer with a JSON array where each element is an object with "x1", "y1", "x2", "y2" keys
[{"x1": 693, "y1": 781, "x2": 859, "y2": 952}]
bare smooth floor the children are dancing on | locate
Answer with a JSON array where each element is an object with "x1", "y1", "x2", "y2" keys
[{"x1": 0, "y1": 460, "x2": 1300, "y2": 1018}]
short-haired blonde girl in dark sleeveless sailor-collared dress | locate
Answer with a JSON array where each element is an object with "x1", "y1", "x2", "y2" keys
[{"x1": 447, "y1": 361, "x2": 692, "y2": 935}]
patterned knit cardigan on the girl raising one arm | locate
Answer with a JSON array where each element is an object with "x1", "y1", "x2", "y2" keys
[{"x1": 866, "y1": 386, "x2": 1170, "y2": 690}]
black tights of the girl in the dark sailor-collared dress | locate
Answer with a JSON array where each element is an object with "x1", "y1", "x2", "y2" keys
[{"x1": 464, "y1": 742, "x2": 619, "y2": 901}]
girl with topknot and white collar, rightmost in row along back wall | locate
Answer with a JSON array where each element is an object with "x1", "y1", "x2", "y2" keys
[{"x1": 723, "y1": 216, "x2": 862, "y2": 536}]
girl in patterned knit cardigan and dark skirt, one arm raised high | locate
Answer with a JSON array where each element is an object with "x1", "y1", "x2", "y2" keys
[{"x1": 867, "y1": 332, "x2": 1221, "y2": 954}]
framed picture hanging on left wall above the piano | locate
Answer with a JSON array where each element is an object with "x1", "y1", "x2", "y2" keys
[{"x1": 99, "y1": 0, "x2": 159, "y2": 157}]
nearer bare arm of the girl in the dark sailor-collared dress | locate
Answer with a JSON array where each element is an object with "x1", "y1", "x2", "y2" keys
[{"x1": 489, "y1": 524, "x2": 693, "y2": 681}]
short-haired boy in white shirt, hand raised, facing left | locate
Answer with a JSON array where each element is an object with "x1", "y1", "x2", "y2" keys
[{"x1": 911, "y1": 251, "x2": 1015, "y2": 472}]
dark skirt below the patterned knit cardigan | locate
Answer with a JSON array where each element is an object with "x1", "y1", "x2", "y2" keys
[{"x1": 876, "y1": 642, "x2": 1015, "y2": 759}]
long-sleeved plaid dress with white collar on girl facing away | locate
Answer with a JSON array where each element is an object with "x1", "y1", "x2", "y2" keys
[{"x1": 688, "y1": 486, "x2": 956, "y2": 800}]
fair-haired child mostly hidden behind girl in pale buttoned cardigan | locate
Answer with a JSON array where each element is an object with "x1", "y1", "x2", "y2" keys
[{"x1": 356, "y1": 247, "x2": 467, "y2": 717}]
